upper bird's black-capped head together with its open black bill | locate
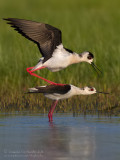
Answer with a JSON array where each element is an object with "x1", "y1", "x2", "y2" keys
[{"x1": 79, "y1": 51, "x2": 102, "y2": 74}]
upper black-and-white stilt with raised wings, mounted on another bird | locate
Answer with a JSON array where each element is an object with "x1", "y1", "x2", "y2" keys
[{"x1": 4, "y1": 18, "x2": 101, "y2": 84}]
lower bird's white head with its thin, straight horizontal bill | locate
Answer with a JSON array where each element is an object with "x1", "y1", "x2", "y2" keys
[{"x1": 82, "y1": 87, "x2": 109, "y2": 95}]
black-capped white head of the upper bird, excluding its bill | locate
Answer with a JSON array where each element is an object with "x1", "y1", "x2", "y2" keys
[{"x1": 79, "y1": 52, "x2": 94, "y2": 64}]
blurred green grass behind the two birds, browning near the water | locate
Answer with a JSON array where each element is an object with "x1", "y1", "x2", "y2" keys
[{"x1": 0, "y1": 0, "x2": 120, "y2": 112}]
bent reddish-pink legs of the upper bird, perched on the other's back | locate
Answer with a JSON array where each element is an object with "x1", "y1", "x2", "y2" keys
[{"x1": 26, "y1": 67, "x2": 64, "y2": 86}]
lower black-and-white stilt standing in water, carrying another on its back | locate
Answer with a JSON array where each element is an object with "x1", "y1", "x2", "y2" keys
[{"x1": 27, "y1": 85, "x2": 108, "y2": 121}]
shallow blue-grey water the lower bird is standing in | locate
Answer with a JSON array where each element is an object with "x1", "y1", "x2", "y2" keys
[{"x1": 0, "y1": 113, "x2": 120, "y2": 160}]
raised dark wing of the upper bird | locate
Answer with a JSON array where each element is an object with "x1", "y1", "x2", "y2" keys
[{"x1": 4, "y1": 18, "x2": 62, "y2": 61}]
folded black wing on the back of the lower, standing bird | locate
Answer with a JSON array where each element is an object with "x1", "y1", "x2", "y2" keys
[{"x1": 35, "y1": 85, "x2": 71, "y2": 94}]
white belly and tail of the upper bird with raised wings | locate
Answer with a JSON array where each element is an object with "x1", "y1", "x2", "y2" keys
[{"x1": 32, "y1": 44, "x2": 72, "y2": 72}]
